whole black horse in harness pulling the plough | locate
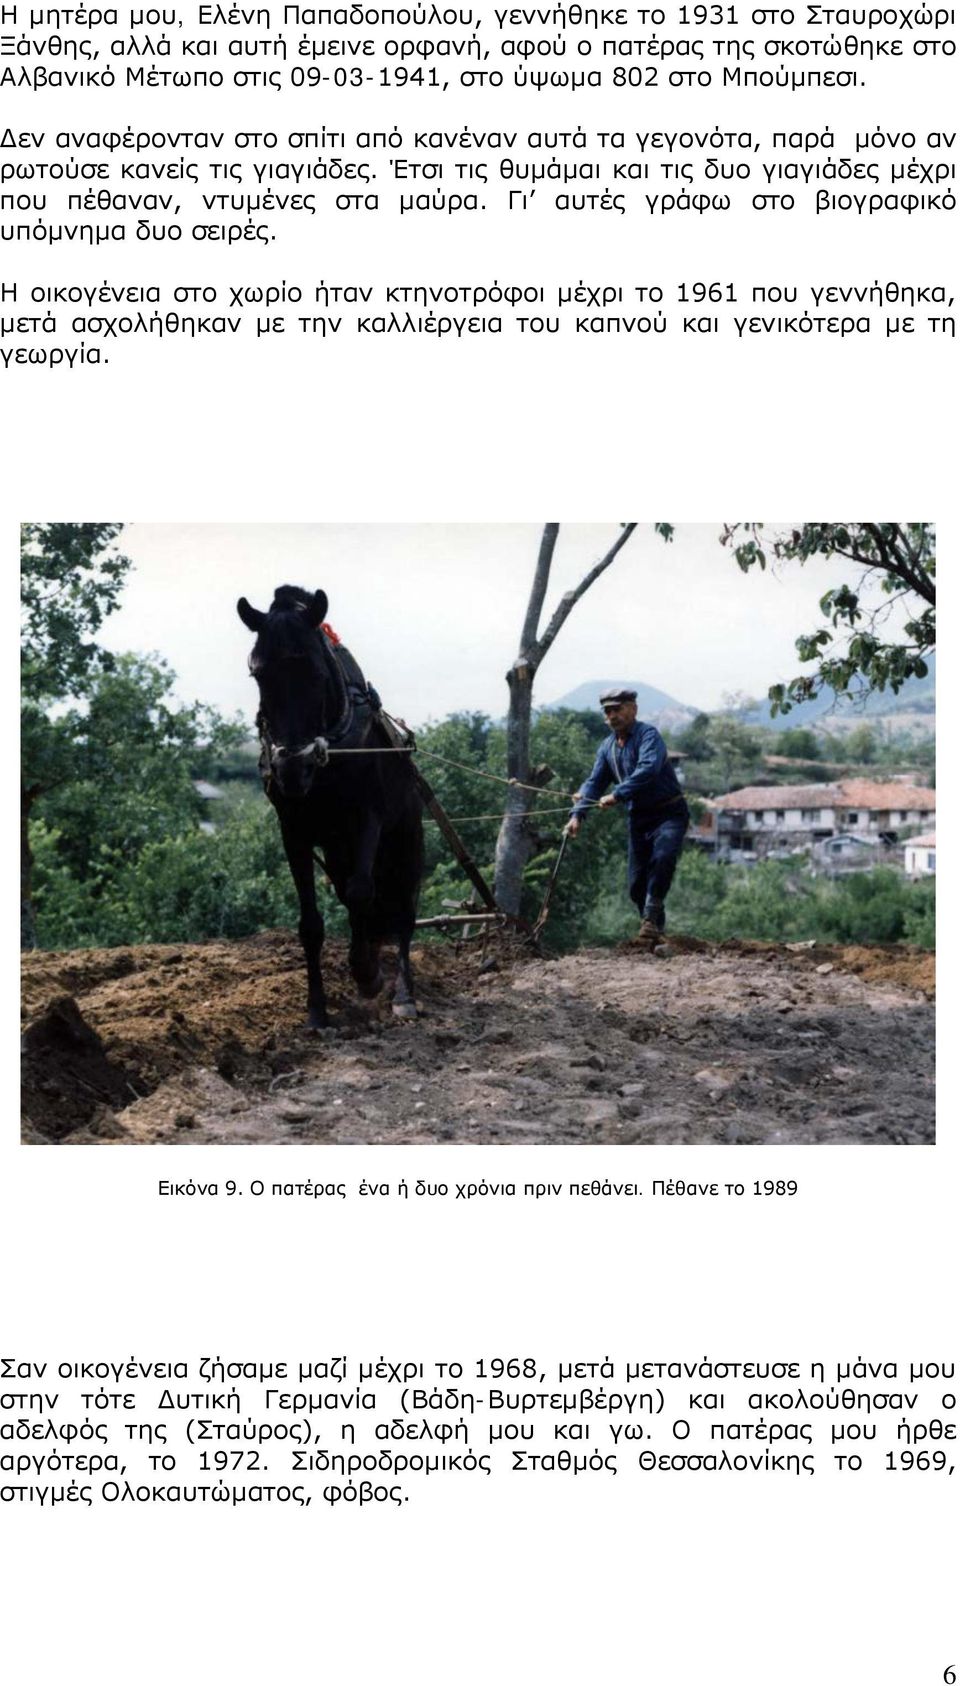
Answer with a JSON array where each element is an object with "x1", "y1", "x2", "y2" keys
[{"x1": 236, "y1": 585, "x2": 423, "y2": 1030}]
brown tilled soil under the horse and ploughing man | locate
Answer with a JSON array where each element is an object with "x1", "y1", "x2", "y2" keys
[{"x1": 24, "y1": 932, "x2": 935, "y2": 1146}]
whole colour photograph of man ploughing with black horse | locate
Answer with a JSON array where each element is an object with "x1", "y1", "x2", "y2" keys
[{"x1": 20, "y1": 521, "x2": 936, "y2": 1146}]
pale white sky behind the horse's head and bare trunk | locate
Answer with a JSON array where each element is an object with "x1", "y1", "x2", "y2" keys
[{"x1": 91, "y1": 521, "x2": 904, "y2": 725}]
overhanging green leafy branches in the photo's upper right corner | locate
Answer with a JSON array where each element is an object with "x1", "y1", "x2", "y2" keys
[{"x1": 720, "y1": 521, "x2": 936, "y2": 715}]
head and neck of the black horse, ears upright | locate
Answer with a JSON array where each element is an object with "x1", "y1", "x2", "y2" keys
[{"x1": 236, "y1": 585, "x2": 349, "y2": 797}]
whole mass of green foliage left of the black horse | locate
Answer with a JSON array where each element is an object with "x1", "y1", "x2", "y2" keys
[{"x1": 20, "y1": 523, "x2": 254, "y2": 946}]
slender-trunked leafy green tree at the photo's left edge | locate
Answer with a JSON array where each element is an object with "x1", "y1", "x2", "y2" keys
[{"x1": 20, "y1": 521, "x2": 130, "y2": 948}]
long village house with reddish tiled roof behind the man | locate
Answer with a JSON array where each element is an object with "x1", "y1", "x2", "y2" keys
[{"x1": 702, "y1": 779, "x2": 936, "y2": 855}]
